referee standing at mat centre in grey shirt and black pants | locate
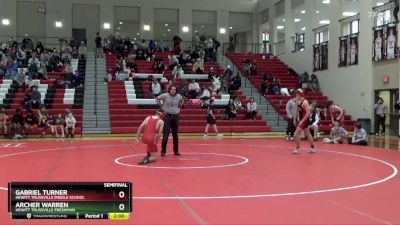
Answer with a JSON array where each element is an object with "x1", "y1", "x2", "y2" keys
[{"x1": 156, "y1": 85, "x2": 183, "y2": 157}]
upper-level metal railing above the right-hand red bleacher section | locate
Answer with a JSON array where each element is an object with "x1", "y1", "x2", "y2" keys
[{"x1": 223, "y1": 42, "x2": 271, "y2": 55}]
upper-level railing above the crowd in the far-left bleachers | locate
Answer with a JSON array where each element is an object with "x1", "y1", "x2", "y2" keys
[{"x1": 0, "y1": 35, "x2": 72, "y2": 49}]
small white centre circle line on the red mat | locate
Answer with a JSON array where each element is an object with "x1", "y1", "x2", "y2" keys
[{"x1": 114, "y1": 152, "x2": 249, "y2": 170}]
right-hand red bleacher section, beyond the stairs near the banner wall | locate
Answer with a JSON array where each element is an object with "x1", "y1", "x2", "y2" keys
[{"x1": 228, "y1": 53, "x2": 354, "y2": 131}]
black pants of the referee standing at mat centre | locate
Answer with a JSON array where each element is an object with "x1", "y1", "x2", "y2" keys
[{"x1": 161, "y1": 114, "x2": 179, "y2": 154}]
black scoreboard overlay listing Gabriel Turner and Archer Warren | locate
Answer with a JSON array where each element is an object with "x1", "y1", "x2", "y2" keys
[{"x1": 8, "y1": 182, "x2": 133, "y2": 220}]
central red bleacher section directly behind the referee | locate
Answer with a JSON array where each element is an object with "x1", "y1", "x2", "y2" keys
[{"x1": 106, "y1": 53, "x2": 271, "y2": 134}]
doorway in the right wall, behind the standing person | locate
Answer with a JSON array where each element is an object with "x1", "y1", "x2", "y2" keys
[{"x1": 375, "y1": 89, "x2": 399, "y2": 136}]
